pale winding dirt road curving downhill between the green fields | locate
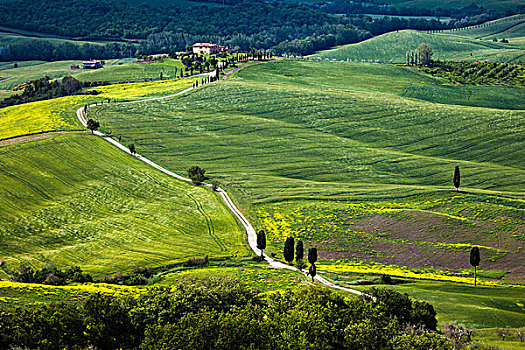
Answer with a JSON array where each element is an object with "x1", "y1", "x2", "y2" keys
[{"x1": 77, "y1": 65, "x2": 363, "y2": 295}]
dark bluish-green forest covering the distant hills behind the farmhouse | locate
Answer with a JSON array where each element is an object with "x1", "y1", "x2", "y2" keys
[{"x1": 0, "y1": 0, "x2": 502, "y2": 60}]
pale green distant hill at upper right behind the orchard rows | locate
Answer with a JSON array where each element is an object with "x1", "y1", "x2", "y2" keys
[{"x1": 313, "y1": 30, "x2": 525, "y2": 63}]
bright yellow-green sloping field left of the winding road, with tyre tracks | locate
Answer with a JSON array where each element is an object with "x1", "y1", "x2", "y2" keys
[{"x1": 0, "y1": 135, "x2": 248, "y2": 274}]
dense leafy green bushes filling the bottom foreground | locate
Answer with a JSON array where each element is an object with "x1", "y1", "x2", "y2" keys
[{"x1": 0, "y1": 280, "x2": 451, "y2": 350}]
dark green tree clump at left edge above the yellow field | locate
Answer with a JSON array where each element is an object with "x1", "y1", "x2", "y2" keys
[{"x1": 0, "y1": 76, "x2": 82, "y2": 108}]
